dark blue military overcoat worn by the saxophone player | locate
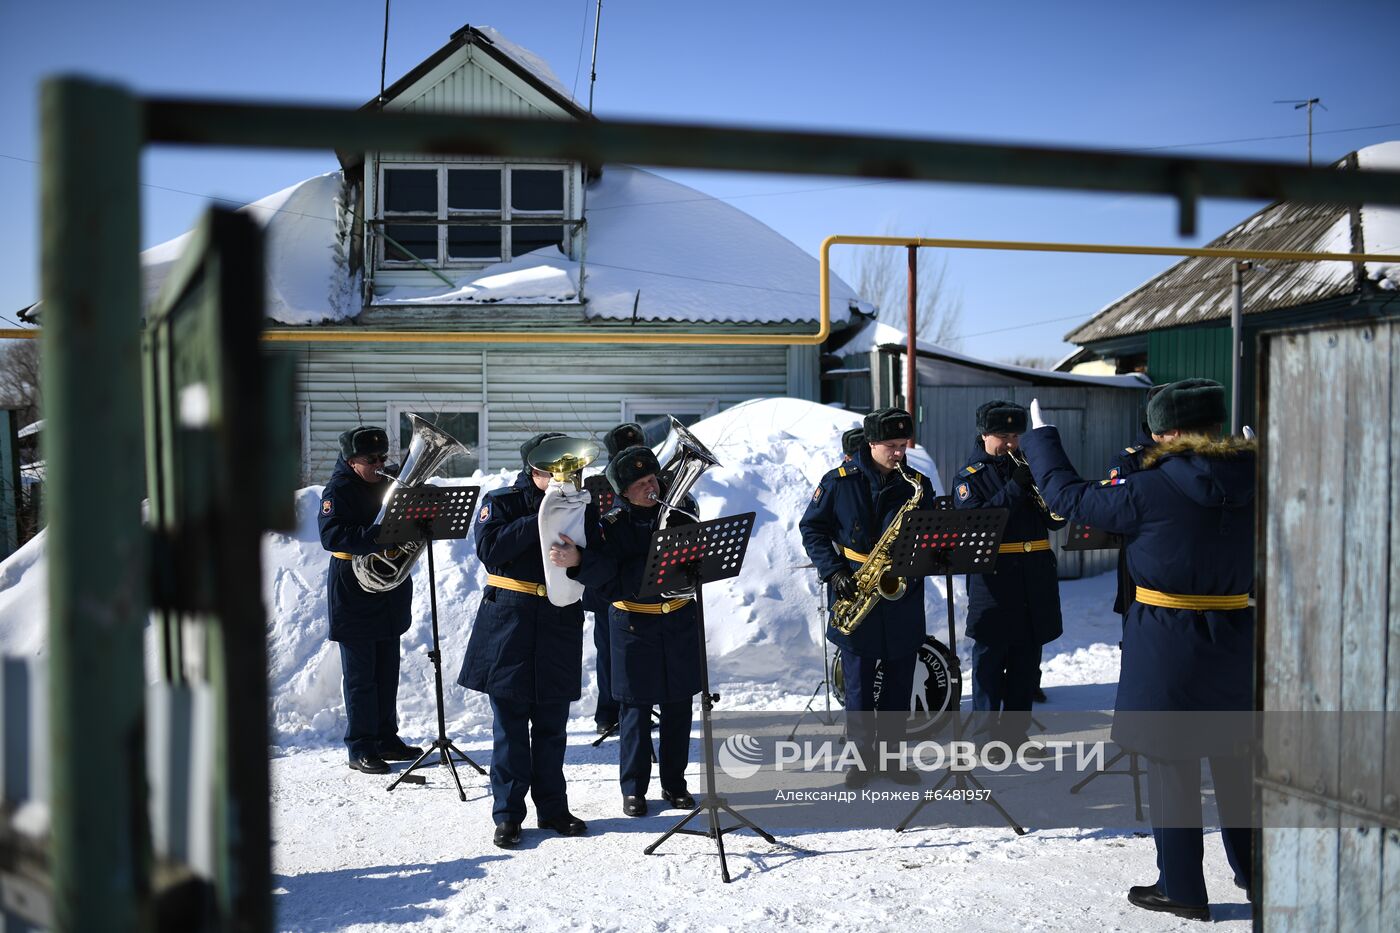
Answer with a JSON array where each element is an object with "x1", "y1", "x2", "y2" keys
[{"x1": 798, "y1": 445, "x2": 934, "y2": 658}]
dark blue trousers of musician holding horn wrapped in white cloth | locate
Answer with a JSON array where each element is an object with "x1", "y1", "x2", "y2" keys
[{"x1": 491, "y1": 696, "x2": 568, "y2": 825}]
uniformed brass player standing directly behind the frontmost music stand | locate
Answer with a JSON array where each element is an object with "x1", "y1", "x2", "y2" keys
[{"x1": 550, "y1": 444, "x2": 701, "y2": 817}]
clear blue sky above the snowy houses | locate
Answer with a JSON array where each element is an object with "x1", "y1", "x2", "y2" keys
[{"x1": 0, "y1": 0, "x2": 1400, "y2": 357}]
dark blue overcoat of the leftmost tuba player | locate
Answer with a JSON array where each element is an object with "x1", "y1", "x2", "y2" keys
[{"x1": 319, "y1": 457, "x2": 413, "y2": 642}]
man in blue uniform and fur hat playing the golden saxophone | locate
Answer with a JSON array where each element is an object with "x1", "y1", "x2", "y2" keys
[{"x1": 798, "y1": 408, "x2": 934, "y2": 787}]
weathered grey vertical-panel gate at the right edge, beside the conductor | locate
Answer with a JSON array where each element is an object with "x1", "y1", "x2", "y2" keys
[{"x1": 1256, "y1": 316, "x2": 1400, "y2": 933}]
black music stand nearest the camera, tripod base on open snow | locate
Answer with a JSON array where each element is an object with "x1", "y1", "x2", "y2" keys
[{"x1": 637, "y1": 511, "x2": 777, "y2": 884}]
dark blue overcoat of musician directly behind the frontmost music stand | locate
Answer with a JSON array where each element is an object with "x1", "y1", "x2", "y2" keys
[{"x1": 575, "y1": 496, "x2": 700, "y2": 705}]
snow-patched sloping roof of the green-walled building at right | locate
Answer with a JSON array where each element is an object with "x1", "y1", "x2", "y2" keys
[{"x1": 1065, "y1": 141, "x2": 1400, "y2": 343}]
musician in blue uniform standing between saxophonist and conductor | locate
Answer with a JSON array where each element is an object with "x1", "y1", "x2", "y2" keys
[{"x1": 953, "y1": 399, "x2": 1065, "y2": 748}]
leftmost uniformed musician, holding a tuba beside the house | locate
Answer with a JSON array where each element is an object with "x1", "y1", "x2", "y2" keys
[{"x1": 319, "y1": 424, "x2": 421, "y2": 775}]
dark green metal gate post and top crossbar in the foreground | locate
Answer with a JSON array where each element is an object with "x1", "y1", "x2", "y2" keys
[{"x1": 41, "y1": 78, "x2": 1400, "y2": 930}]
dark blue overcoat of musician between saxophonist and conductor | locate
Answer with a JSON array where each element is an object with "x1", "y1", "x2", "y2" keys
[{"x1": 953, "y1": 440, "x2": 1065, "y2": 644}]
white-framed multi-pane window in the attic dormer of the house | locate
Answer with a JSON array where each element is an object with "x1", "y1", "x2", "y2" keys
[{"x1": 374, "y1": 161, "x2": 574, "y2": 272}]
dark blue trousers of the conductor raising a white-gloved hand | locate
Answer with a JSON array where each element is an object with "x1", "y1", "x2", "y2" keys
[{"x1": 1147, "y1": 755, "x2": 1253, "y2": 906}]
